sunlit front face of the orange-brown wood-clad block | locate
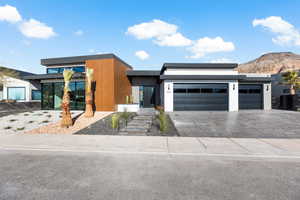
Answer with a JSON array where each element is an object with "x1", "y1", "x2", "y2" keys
[{"x1": 86, "y1": 59, "x2": 116, "y2": 111}]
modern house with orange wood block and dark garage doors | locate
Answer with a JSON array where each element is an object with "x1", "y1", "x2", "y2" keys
[{"x1": 24, "y1": 54, "x2": 271, "y2": 112}]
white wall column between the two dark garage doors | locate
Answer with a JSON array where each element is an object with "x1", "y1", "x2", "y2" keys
[{"x1": 228, "y1": 81, "x2": 239, "y2": 111}]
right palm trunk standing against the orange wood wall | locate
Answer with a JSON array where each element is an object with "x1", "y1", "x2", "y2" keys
[{"x1": 84, "y1": 68, "x2": 94, "y2": 117}]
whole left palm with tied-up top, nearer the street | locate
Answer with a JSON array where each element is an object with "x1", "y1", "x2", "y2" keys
[{"x1": 60, "y1": 70, "x2": 74, "y2": 128}]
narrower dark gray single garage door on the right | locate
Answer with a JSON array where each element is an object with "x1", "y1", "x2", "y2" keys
[{"x1": 239, "y1": 84, "x2": 263, "y2": 109}]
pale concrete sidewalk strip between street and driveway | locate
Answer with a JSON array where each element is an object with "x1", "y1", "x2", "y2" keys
[{"x1": 0, "y1": 134, "x2": 300, "y2": 158}]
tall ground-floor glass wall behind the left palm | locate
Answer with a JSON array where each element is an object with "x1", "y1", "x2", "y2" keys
[{"x1": 42, "y1": 81, "x2": 85, "y2": 110}]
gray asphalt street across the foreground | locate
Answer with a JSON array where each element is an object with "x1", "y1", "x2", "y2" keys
[{"x1": 0, "y1": 150, "x2": 300, "y2": 200}]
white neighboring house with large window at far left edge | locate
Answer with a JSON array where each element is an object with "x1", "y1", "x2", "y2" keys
[{"x1": 2, "y1": 69, "x2": 41, "y2": 102}]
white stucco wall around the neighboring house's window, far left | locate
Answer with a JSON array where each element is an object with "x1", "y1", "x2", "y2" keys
[{"x1": 3, "y1": 77, "x2": 39, "y2": 101}]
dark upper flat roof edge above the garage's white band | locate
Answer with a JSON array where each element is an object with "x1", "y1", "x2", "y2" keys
[{"x1": 161, "y1": 63, "x2": 238, "y2": 74}]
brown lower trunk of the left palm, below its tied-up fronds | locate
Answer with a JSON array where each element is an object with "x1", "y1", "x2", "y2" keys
[{"x1": 60, "y1": 90, "x2": 73, "y2": 128}]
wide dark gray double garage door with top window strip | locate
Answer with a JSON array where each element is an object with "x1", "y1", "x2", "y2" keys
[{"x1": 174, "y1": 83, "x2": 228, "y2": 110}]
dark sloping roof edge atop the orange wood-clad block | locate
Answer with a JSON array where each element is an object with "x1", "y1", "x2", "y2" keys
[{"x1": 41, "y1": 53, "x2": 132, "y2": 69}]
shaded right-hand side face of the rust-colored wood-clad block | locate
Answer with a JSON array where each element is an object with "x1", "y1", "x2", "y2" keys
[{"x1": 114, "y1": 59, "x2": 131, "y2": 104}]
